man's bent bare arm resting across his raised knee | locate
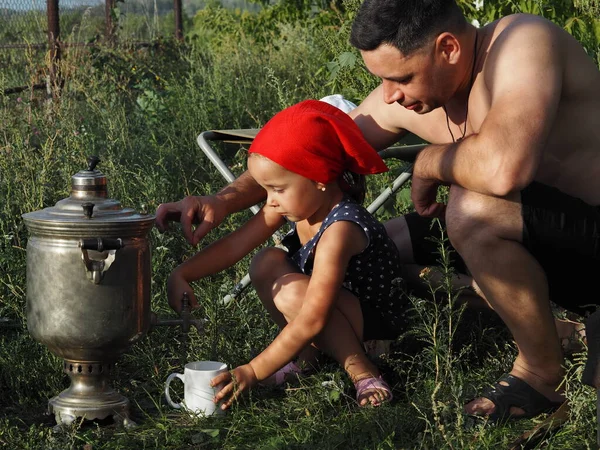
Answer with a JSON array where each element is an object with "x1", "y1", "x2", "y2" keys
[{"x1": 413, "y1": 18, "x2": 563, "y2": 200}]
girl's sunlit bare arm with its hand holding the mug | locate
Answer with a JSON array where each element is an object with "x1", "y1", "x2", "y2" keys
[{"x1": 213, "y1": 221, "x2": 367, "y2": 409}]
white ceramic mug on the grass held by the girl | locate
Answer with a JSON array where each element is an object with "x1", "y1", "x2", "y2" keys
[{"x1": 165, "y1": 361, "x2": 227, "y2": 416}]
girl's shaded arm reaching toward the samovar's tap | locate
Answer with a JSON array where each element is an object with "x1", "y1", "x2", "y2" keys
[{"x1": 167, "y1": 208, "x2": 285, "y2": 312}]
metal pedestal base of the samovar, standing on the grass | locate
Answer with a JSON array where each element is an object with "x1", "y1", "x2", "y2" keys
[{"x1": 48, "y1": 360, "x2": 136, "y2": 428}]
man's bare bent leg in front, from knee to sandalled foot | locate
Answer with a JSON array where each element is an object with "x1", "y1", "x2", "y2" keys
[{"x1": 446, "y1": 186, "x2": 563, "y2": 415}]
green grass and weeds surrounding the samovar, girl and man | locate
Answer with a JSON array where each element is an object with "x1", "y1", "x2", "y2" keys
[{"x1": 0, "y1": 2, "x2": 596, "y2": 450}]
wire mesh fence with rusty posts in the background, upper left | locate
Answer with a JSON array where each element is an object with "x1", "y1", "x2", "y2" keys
[{"x1": 0, "y1": 0, "x2": 183, "y2": 93}]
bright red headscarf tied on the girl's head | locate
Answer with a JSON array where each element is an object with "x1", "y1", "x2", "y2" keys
[{"x1": 248, "y1": 100, "x2": 388, "y2": 184}]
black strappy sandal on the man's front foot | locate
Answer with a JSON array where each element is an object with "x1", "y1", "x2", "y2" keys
[{"x1": 481, "y1": 373, "x2": 564, "y2": 423}]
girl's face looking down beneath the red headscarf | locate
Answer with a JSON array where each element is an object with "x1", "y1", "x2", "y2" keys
[{"x1": 248, "y1": 153, "x2": 326, "y2": 222}]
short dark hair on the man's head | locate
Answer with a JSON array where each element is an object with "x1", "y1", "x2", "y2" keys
[{"x1": 350, "y1": 0, "x2": 467, "y2": 56}]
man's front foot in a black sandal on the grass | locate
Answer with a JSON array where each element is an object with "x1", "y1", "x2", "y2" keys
[{"x1": 465, "y1": 374, "x2": 565, "y2": 422}]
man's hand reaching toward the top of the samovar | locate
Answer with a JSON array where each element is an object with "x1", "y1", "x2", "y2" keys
[{"x1": 155, "y1": 195, "x2": 227, "y2": 246}]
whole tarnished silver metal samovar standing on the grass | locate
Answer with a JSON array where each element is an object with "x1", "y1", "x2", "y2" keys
[{"x1": 23, "y1": 156, "x2": 154, "y2": 426}]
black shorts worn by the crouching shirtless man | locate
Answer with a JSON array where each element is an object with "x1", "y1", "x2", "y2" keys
[{"x1": 406, "y1": 182, "x2": 600, "y2": 315}]
